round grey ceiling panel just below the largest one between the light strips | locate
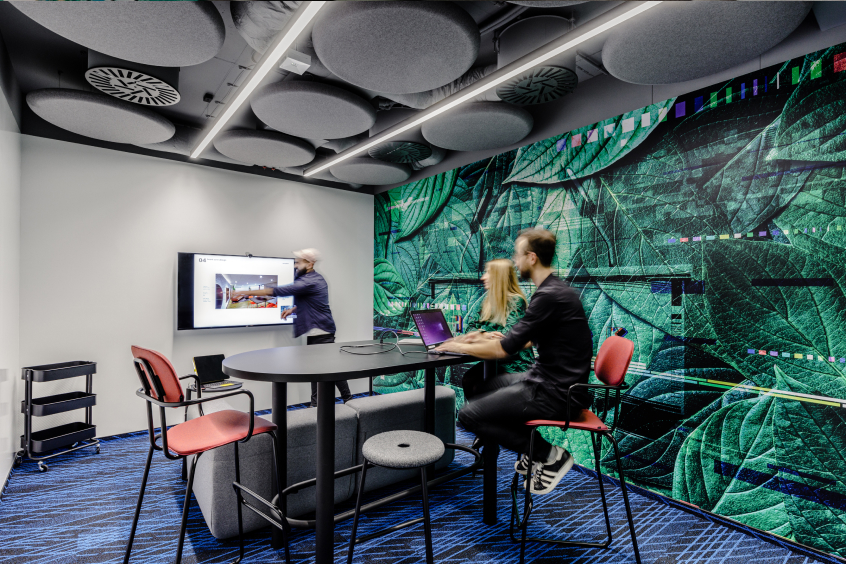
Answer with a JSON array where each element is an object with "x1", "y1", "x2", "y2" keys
[{"x1": 250, "y1": 80, "x2": 376, "y2": 139}]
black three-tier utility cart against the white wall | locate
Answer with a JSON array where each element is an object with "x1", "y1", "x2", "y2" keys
[{"x1": 15, "y1": 360, "x2": 100, "y2": 472}]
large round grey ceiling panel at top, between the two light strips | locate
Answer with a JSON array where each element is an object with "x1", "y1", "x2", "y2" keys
[{"x1": 312, "y1": 2, "x2": 480, "y2": 94}]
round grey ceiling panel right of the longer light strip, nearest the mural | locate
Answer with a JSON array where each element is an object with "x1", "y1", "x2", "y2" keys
[{"x1": 422, "y1": 102, "x2": 534, "y2": 151}]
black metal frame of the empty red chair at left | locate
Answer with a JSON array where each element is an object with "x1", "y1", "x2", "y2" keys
[{"x1": 123, "y1": 358, "x2": 270, "y2": 564}]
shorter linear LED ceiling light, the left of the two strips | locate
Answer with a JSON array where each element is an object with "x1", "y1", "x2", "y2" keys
[{"x1": 191, "y1": 2, "x2": 326, "y2": 159}]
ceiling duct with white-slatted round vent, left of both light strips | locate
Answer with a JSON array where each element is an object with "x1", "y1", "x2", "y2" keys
[{"x1": 85, "y1": 49, "x2": 180, "y2": 106}]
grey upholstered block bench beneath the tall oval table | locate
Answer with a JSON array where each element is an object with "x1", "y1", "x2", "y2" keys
[{"x1": 188, "y1": 386, "x2": 455, "y2": 539}]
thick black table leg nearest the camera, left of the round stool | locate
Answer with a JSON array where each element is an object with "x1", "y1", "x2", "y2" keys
[{"x1": 315, "y1": 382, "x2": 335, "y2": 564}]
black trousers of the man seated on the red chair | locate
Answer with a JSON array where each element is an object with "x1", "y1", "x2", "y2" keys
[{"x1": 458, "y1": 373, "x2": 581, "y2": 462}]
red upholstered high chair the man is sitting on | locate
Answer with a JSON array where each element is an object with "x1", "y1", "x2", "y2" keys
[{"x1": 509, "y1": 336, "x2": 640, "y2": 564}]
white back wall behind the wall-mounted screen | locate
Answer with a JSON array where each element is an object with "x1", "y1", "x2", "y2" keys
[{"x1": 20, "y1": 135, "x2": 373, "y2": 436}]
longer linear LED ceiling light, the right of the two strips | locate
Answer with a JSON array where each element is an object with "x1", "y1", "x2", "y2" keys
[{"x1": 303, "y1": 2, "x2": 661, "y2": 176}]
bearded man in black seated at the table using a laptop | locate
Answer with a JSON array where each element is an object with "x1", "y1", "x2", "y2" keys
[{"x1": 436, "y1": 229, "x2": 593, "y2": 494}]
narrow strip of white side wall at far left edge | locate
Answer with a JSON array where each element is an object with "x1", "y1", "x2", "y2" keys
[{"x1": 0, "y1": 47, "x2": 20, "y2": 480}]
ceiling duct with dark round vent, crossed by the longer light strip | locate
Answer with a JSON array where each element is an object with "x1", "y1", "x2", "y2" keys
[{"x1": 496, "y1": 16, "x2": 579, "y2": 106}]
